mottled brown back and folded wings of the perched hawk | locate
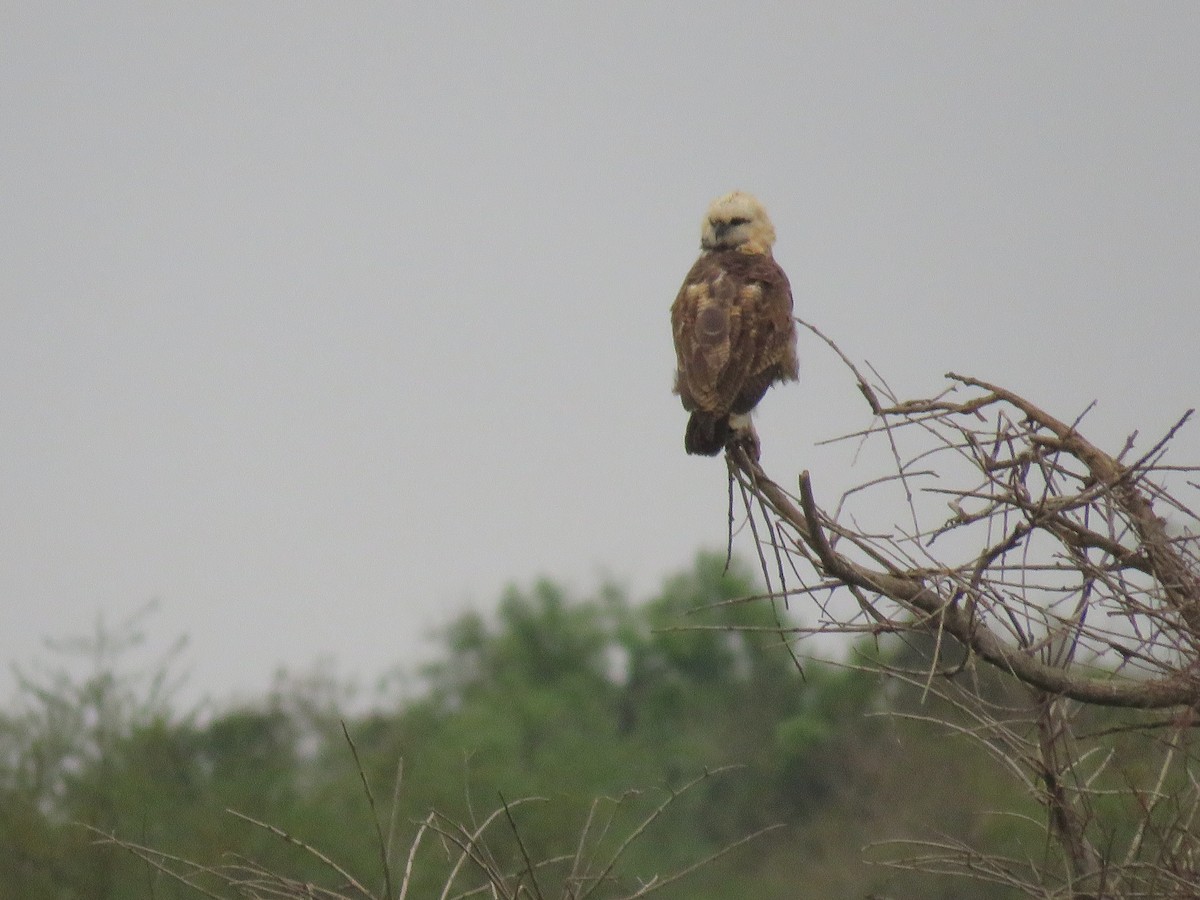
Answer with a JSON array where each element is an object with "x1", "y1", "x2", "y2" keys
[{"x1": 671, "y1": 251, "x2": 797, "y2": 415}]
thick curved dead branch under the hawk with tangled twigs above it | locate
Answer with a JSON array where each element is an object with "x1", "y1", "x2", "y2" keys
[{"x1": 730, "y1": 367, "x2": 1200, "y2": 708}]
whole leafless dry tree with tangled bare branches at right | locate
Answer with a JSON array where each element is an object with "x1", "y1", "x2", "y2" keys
[{"x1": 726, "y1": 322, "x2": 1200, "y2": 898}]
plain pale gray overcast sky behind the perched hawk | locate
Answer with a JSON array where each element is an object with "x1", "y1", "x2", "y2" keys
[{"x1": 0, "y1": 1, "x2": 1200, "y2": 710}]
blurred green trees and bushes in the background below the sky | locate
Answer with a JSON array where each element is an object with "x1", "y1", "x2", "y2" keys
[{"x1": 0, "y1": 554, "x2": 1147, "y2": 900}]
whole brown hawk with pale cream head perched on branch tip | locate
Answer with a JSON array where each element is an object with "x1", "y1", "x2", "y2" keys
[{"x1": 671, "y1": 191, "x2": 798, "y2": 456}]
